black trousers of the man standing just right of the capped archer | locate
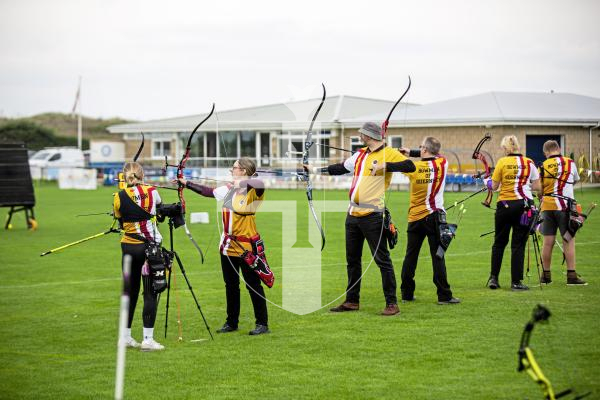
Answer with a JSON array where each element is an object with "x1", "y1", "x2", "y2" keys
[{"x1": 400, "y1": 213, "x2": 452, "y2": 301}]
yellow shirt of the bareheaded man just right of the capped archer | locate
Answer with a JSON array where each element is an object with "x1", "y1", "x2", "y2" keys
[{"x1": 406, "y1": 157, "x2": 448, "y2": 222}]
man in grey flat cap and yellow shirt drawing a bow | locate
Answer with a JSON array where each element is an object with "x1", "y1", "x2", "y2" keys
[{"x1": 320, "y1": 122, "x2": 415, "y2": 316}]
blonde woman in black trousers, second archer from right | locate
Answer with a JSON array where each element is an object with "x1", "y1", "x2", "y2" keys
[{"x1": 486, "y1": 135, "x2": 540, "y2": 291}]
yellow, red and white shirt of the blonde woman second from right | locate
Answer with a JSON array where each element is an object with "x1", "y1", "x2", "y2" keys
[{"x1": 492, "y1": 154, "x2": 540, "y2": 201}]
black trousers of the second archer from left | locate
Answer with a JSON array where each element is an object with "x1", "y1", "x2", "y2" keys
[{"x1": 221, "y1": 254, "x2": 269, "y2": 328}]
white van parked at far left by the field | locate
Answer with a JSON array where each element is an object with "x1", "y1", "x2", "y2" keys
[{"x1": 29, "y1": 147, "x2": 85, "y2": 179}]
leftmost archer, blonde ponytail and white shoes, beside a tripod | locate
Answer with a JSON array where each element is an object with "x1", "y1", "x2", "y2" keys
[{"x1": 113, "y1": 162, "x2": 164, "y2": 351}]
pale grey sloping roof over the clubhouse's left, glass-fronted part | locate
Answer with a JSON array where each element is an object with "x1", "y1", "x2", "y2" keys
[{"x1": 107, "y1": 95, "x2": 416, "y2": 133}]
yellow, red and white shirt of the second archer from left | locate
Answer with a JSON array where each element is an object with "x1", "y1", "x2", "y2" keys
[{"x1": 213, "y1": 185, "x2": 265, "y2": 257}]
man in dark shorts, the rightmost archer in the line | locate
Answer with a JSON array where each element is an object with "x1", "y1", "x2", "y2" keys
[{"x1": 540, "y1": 140, "x2": 587, "y2": 286}]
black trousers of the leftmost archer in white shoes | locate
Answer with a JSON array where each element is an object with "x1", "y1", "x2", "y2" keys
[{"x1": 121, "y1": 243, "x2": 158, "y2": 328}]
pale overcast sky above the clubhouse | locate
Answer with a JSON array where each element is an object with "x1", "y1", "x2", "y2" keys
[{"x1": 0, "y1": 0, "x2": 600, "y2": 120}]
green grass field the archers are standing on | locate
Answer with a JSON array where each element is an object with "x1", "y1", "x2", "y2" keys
[{"x1": 0, "y1": 184, "x2": 600, "y2": 399}]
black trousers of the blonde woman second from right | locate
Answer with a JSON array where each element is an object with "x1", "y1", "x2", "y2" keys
[{"x1": 491, "y1": 200, "x2": 529, "y2": 282}]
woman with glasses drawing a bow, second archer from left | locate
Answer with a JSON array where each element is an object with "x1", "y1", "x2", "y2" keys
[{"x1": 179, "y1": 158, "x2": 272, "y2": 335}]
